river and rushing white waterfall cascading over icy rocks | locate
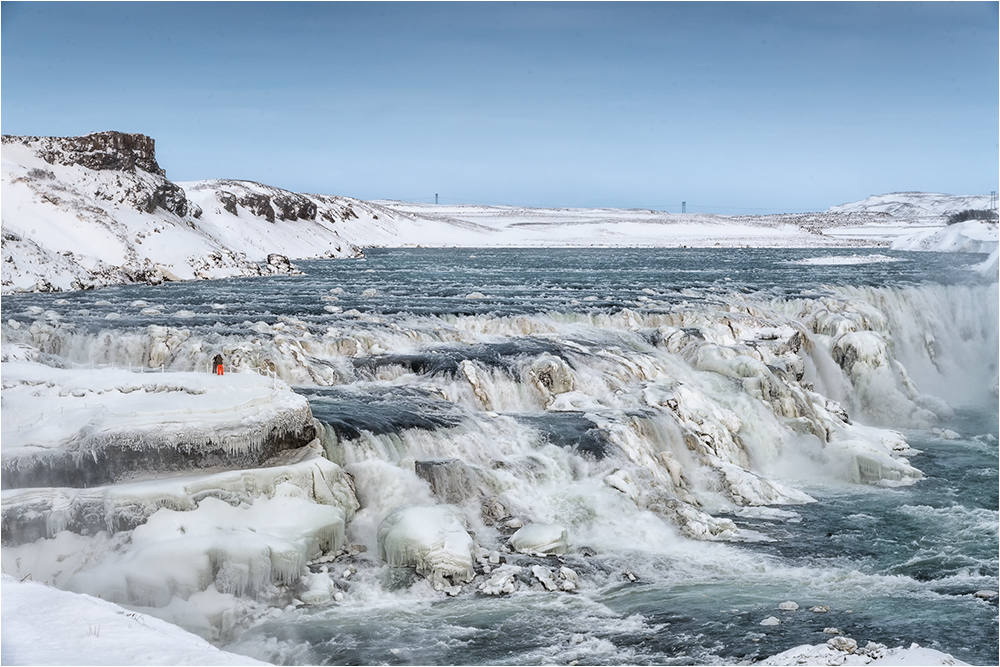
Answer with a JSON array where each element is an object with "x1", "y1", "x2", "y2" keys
[{"x1": 2, "y1": 250, "x2": 998, "y2": 664}]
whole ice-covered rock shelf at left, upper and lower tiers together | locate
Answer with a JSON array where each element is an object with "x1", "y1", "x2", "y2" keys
[{"x1": 2, "y1": 358, "x2": 358, "y2": 639}]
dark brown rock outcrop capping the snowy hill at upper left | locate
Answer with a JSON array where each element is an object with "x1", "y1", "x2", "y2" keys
[{"x1": 3, "y1": 131, "x2": 166, "y2": 176}]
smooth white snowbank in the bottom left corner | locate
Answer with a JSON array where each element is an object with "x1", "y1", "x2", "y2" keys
[{"x1": 0, "y1": 574, "x2": 268, "y2": 665}]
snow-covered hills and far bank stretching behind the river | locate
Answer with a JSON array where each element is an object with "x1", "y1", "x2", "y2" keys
[{"x1": 2, "y1": 132, "x2": 989, "y2": 293}]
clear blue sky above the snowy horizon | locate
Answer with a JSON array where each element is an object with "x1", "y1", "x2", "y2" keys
[{"x1": 0, "y1": 2, "x2": 1000, "y2": 213}]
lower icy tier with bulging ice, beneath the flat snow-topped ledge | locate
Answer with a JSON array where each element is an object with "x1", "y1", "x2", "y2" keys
[{"x1": 2, "y1": 441, "x2": 358, "y2": 640}]
